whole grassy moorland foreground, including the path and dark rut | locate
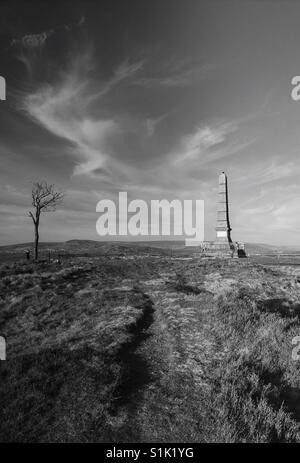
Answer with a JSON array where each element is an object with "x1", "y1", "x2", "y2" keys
[{"x1": 0, "y1": 248, "x2": 300, "y2": 442}]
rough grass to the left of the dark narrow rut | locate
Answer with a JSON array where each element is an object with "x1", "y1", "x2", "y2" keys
[{"x1": 0, "y1": 261, "x2": 157, "y2": 442}]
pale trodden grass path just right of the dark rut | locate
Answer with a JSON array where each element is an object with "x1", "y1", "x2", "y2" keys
[{"x1": 116, "y1": 274, "x2": 221, "y2": 442}]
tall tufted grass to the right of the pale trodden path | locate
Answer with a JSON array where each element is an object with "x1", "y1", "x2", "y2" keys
[{"x1": 210, "y1": 288, "x2": 300, "y2": 442}]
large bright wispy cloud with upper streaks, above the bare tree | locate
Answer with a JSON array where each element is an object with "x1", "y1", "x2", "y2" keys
[{"x1": 23, "y1": 50, "x2": 142, "y2": 175}]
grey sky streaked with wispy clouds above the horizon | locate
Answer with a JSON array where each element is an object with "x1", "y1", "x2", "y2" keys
[{"x1": 0, "y1": 0, "x2": 300, "y2": 245}]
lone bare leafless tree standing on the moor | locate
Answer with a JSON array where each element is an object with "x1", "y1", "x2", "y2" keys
[{"x1": 28, "y1": 182, "x2": 64, "y2": 260}]
